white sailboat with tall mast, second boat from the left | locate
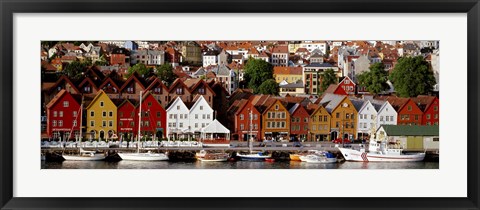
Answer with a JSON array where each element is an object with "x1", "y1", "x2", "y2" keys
[{"x1": 118, "y1": 91, "x2": 168, "y2": 161}]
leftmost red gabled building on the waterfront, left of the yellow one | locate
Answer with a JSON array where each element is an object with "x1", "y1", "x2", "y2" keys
[{"x1": 46, "y1": 89, "x2": 80, "y2": 140}]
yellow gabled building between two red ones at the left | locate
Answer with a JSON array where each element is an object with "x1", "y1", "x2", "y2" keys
[{"x1": 84, "y1": 90, "x2": 117, "y2": 141}]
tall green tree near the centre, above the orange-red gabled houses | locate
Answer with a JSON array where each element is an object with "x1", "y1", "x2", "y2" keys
[{"x1": 244, "y1": 59, "x2": 274, "y2": 93}]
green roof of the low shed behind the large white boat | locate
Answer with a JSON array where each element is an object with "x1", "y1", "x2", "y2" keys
[{"x1": 381, "y1": 125, "x2": 440, "y2": 136}]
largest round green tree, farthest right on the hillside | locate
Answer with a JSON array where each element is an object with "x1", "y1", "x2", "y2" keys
[{"x1": 390, "y1": 56, "x2": 436, "y2": 97}]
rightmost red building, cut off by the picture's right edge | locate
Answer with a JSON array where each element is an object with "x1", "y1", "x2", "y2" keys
[{"x1": 412, "y1": 95, "x2": 440, "y2": 125}]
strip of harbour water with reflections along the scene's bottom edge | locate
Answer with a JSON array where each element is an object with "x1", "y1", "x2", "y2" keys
[{"x1": 41, "y1": 160, "x2": 439, "y2": 169}]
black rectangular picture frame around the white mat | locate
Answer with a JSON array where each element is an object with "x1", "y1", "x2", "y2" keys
[{"x1": 0, "y1": 0, "x2": 480, "y2": 209}]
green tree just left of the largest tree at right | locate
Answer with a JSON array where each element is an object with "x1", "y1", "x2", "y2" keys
[{"x1": 358, "y1": 63, "x2": 390, "y2": 94}]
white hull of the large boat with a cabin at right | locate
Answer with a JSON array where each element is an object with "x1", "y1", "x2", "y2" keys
[{"x1": 338, "y1": 148, "x2": 425, "y2": 162}]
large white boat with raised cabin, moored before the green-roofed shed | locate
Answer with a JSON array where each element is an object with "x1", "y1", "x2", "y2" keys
[{"x1": 338, "y1": 120, "x2": 425, "y2": 162}]
